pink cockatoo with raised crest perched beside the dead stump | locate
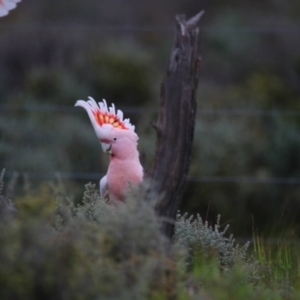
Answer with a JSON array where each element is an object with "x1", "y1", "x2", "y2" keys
[{"x1": 75, "y1": 97, "x2": 143, "y2": 203}]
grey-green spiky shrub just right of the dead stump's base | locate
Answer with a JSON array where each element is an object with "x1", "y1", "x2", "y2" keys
[{"x1": 174, "y1": 213, "x2": 250, "y2": 270}]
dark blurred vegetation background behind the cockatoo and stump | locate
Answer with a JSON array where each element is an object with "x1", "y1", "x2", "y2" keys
[{"x1": 0, "y1": 0, "x2": 300, "y2": 238}]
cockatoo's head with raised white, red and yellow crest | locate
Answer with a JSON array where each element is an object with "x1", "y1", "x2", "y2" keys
[{"x1": 75, "y1": 97, "x2": 138, "y2": 159}]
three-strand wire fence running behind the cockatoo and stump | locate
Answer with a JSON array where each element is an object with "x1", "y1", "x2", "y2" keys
[{"x1": 0, "y1": 23, "x2": 300, "y2": 185}]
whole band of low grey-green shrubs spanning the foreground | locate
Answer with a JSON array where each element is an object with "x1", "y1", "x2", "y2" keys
[{"x1": 0, "y1": 177, "x2": 299, "y2": 300}]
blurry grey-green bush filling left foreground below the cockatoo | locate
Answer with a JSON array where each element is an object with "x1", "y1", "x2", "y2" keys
[{"x1": 0, "y1": 184, "x2": 170, "y2": 299}]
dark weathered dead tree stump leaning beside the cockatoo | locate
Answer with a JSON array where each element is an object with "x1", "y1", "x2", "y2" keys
[{"x1": 148, "y1": 11, "x2": 203, "y2": 238}]
